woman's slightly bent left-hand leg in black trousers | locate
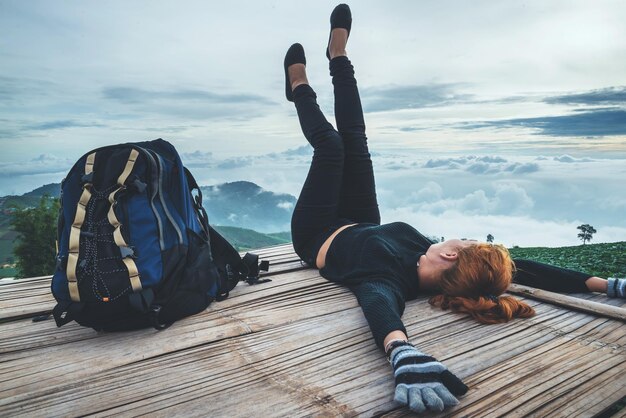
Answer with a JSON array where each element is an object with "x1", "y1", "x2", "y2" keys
[{"x1": 291, "y1": 64, "x2": 344, "y2": 266}]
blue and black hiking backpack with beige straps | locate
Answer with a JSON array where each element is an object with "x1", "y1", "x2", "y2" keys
[{"x1": 52, "y1": 139, "x2": 269, "y2": 331}]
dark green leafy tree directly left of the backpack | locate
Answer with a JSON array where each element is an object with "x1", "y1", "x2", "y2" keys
[{"x1": 11, "y1": 195, "x2": 59, "y2": 277}]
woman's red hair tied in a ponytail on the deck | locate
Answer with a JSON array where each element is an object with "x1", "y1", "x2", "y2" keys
[{"x1": 429, "y1": 244, "x2": 535, "y2": 324}]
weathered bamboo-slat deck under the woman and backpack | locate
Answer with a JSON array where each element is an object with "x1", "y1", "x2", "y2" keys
[{"x1": 0, "y1": 245, "x2": 626, "y2": 417}]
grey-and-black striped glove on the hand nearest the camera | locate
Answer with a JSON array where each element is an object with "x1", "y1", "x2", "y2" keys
[{"x1": 389, "y1": 342, "x2": 467, "y2": 412}]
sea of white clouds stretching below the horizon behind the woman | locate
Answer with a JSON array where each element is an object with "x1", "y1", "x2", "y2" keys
[{"x1": 0, "y1": 145, "x2": 626, "y2": 247}]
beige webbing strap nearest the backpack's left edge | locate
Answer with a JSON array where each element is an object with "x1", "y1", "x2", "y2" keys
[{"x1": 66, "y1": 152, "x2": 96, "y2": 302}]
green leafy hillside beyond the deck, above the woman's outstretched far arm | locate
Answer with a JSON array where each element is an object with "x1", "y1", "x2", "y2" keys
[{"x1": 510, "y1": 241, "x2": 626, "y2": 277}]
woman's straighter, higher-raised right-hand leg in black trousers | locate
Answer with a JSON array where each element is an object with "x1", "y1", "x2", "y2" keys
[{"x1": 329, "y1": 28, "x2": 380, "y2": 224}]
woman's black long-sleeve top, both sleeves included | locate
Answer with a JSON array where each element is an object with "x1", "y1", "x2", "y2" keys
[{"x1": 320, "y1": 222, "x2": 590, "y2": 348}]
